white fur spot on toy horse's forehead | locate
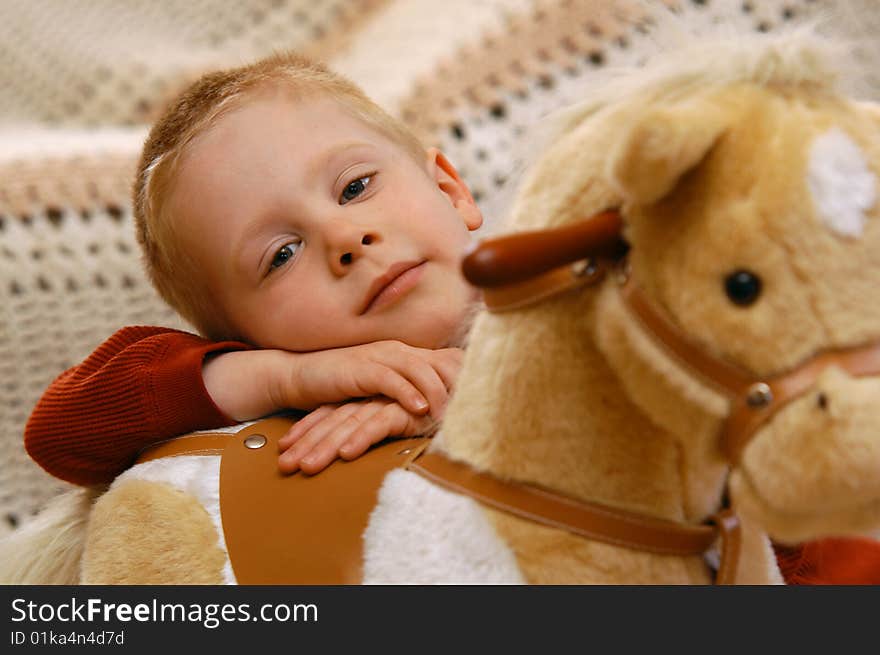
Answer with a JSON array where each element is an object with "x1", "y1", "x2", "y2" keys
[{"x1": 807, "y1": 127, "x2": 877, "y2": 237}]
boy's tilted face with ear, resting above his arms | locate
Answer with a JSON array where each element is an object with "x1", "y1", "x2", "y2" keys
[{"x1": 170, "y1": 88, "x2": 482, "y2": 351}]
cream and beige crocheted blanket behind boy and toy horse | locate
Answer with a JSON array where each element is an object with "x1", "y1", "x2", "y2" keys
[{"x1": 0, "y1": 0, "x2": 880, "y2": 534}]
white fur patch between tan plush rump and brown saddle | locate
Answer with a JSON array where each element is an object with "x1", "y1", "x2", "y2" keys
[{"x1": 111, "y1": 455, "x2": 237, "y2": 584}]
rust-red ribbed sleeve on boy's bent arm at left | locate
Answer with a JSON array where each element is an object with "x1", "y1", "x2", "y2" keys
[{"x1": 24, "y1": 326, "x2": 249, "y2": 485}]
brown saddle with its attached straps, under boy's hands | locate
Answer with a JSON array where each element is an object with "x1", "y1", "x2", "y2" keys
[{"x1": 137, "y1": 417, "x2": 740, "y2": 585}]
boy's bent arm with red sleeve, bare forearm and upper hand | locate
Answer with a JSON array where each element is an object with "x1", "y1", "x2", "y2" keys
[{"x1": 25, "y1": 327, "x2": 461, "y2": 485}]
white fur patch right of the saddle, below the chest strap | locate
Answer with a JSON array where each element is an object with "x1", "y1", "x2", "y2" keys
[{"x1": 364, "y1": 470, "x2": 525, "y2": 584}]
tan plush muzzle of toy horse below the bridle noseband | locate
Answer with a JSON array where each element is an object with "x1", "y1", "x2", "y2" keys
[{"x1": 731, "y1": 369, "x2": 880, "y2": 542}]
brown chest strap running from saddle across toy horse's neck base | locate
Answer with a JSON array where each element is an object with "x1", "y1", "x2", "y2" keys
[{"x1": 407, "y1": 452, "x2": 717, "y2": 555}]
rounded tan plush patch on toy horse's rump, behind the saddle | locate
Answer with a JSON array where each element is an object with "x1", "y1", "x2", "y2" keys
[{"x1": 82, "y1": 480, "x2": 226, "y2": 584}]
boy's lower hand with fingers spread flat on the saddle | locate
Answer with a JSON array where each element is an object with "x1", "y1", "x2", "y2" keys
[{"x1": 278, "y1": 398, "x2": 437, "y2": 474}]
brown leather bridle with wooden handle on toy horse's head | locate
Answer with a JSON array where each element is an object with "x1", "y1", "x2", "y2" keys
[{"x1": 462, "y1": 209, "x2": 880, "y2": 466}]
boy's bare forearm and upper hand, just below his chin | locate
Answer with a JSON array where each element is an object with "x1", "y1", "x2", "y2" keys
[{"x1": 202, "y1": 341, "x2": 463, "y2": 421}]
